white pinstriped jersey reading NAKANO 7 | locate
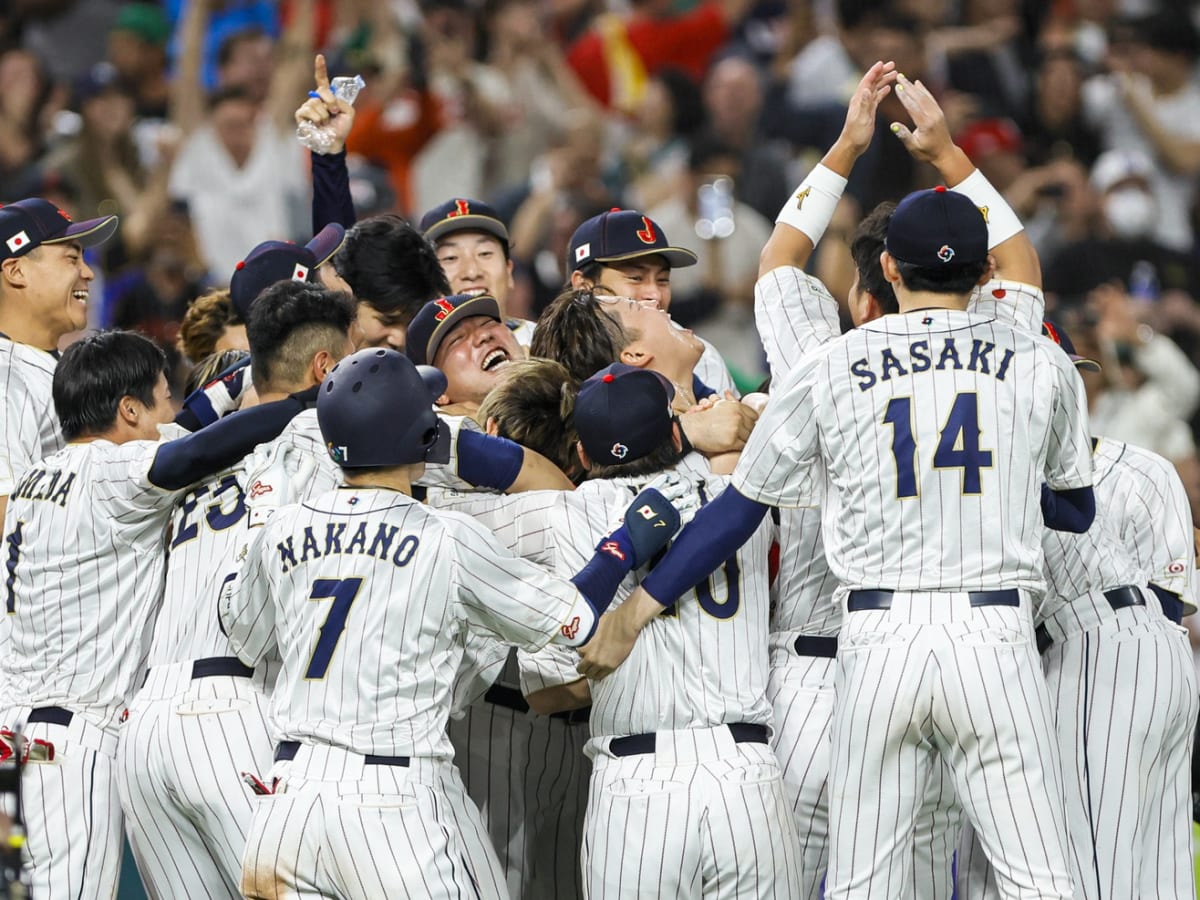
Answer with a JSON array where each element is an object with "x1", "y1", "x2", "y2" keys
[{"x1": 221, "y1": 488, "x2": 583, "y2": 757}]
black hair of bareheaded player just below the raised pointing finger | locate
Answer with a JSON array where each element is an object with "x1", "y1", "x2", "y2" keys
[{"x1": 334, "y1": 214, "x2": 450, "y2": 325}]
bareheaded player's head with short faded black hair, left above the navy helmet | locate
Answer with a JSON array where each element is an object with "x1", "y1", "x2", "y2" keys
[{"x1": 246, "y1": 281, "x2": 355, "y2": 392}]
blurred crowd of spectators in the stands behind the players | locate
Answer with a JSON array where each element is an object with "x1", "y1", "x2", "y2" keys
[{"x1": 0, "y1": 0, "x2": 1200, "y2": 504}]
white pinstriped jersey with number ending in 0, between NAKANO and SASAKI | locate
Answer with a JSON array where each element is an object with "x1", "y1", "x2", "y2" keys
[{"x1": 436, "y1": 476, "x2": 773, "y2": 736}]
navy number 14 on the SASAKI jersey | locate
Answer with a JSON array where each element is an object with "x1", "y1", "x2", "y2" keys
[{"x1": 883, "y1": 394, "x2": 991, "y2": 499}]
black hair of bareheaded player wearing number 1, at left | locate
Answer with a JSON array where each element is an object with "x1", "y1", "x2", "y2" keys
[{"x1": 52, "y1": 330, "x2": 168, "y2": 440}]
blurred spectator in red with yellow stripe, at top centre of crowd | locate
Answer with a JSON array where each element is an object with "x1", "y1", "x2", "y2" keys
[{"x1": 566, "y1": 0, "x2": 750, "y2": 113}]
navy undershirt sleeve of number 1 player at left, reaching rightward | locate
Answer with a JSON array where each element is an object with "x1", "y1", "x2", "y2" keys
[{"x1": 149, "y1": 397, "x2": 305, "y2": 491}]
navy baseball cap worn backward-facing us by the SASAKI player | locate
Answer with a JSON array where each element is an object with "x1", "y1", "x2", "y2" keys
[{"x1": 884, "y1": 186, "x2": 988, "y2": 269}]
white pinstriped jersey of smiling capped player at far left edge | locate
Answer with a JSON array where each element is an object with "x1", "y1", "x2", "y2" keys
[{"x1": 0, "y1": 337, "x2": 66, "y2": 496}]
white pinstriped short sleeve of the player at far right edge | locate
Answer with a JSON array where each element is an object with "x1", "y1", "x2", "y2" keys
[{"x1": 1092, "y1": 438, "x2": 1195, "y2": 604}]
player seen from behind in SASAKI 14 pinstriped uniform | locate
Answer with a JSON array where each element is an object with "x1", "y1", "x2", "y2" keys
[{"x1": 581, "y1": 188, "x2": 1094, "y2": 899}]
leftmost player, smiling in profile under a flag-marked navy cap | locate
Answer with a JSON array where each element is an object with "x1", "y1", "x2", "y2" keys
[{"x1": 0, "y1": 198, "x2": 118, "y2": 514}]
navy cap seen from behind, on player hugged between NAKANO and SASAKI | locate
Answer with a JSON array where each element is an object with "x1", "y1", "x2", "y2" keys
[{"x1": 575, "y1": 362, "x2": 674, "y2": 466}]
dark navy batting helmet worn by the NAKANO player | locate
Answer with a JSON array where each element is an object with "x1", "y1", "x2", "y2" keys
[{"x1": 317, "y1": 348, "x2": 440, "y2": 469}]
